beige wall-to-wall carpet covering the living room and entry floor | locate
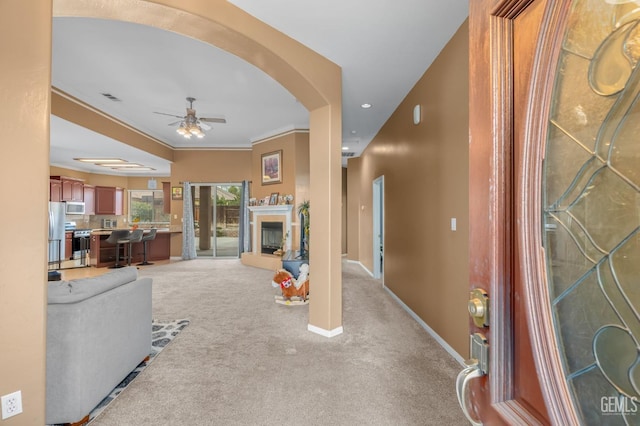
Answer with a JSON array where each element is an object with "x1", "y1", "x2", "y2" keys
[{"x1": 92, "y1": 259, "x2": 468, "y2": 426}]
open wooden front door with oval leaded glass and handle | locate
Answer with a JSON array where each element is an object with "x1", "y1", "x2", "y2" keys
[{"x1": 458, "y1": 0, "x2": 640, "y2": 425}]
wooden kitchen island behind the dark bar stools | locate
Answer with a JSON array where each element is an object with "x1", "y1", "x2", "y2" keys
[{"x1": 89, "y1": 228, "x2": 182, "y2": 268}]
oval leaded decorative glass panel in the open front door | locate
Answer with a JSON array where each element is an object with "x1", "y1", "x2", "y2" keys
[{"x1": 542, "y1": 0, "x2": 640, "y2": 425}]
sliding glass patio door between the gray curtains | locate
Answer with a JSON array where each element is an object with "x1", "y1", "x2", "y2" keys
[{"x1": 192, "y1": 183, "x2": 242, "y2": 258}]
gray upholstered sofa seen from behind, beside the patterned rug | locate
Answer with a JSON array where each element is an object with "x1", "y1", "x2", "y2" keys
[{"x1": 45, "y1": 267, "x2": 152, "y2": 424}]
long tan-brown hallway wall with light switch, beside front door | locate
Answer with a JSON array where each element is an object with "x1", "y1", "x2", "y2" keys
[{"x1": 348, "y1": 22, "x2": 469, "y2": 356}]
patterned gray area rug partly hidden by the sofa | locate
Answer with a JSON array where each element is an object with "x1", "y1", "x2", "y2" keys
[{"x1": 50, "y1": 319, "x2": 189, "y2": 426}]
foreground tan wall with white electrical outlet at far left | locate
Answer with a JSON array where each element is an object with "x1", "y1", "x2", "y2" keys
[{"x1": 0, "y1": 0, "x2": 51, "y2": 426}]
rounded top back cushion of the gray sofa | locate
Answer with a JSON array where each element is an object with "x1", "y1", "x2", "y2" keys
[{"x1": 47, "y1": 266, "x2": 138, "y2": 304}]
